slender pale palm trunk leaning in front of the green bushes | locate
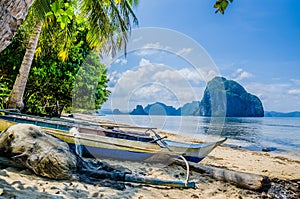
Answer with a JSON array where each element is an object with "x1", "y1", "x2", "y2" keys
[{"x1": 8, "y1": 21, "x2": 43, "y2": 110}]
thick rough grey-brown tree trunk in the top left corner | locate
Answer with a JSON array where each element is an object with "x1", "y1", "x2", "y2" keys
[{"x1": 0, "y1": 0, "x2": 34, "y2": 52}]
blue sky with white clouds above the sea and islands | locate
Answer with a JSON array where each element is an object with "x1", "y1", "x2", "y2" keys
[{"x1": 104, "y1": 0, "x2": 300, "y2": 112}]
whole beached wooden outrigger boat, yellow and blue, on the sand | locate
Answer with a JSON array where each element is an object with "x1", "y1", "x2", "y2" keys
[{"x1": 0, "y1": 110, "x2": 226, "y2": 162}]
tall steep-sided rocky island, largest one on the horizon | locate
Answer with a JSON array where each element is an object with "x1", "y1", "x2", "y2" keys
[{"x1": 200, "y1": 77, "x2": 264, "y2": 117}]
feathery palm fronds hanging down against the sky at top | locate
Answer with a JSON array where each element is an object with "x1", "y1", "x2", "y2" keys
[{"x1": 80, "y1": 0, "x2": 138, "y2": 54}]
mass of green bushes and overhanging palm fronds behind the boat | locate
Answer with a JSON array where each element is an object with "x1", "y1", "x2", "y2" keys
[{"x1": 0, "y1": 0, "x2": 138, "y2": 115}]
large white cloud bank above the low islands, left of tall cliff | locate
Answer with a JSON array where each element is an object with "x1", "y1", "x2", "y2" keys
[{"x1": 104, "y1": 58, "x2": 205, "y2": 111}]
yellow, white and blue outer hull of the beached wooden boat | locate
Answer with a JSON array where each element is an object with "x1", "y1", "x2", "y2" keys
[{"x1": 0, "y1": 120, "x2": 225, "y2": 163}]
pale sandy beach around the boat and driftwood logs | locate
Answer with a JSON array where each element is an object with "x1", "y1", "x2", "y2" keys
[{"x1": 0, "y1": 116, "x2": 300, "y2": 199}]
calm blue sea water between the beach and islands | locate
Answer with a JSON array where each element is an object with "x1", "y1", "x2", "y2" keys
[{"x1": 100, "y1": 115, "x2": 300, "y2": 155}]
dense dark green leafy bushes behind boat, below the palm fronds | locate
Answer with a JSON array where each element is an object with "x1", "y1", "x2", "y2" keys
[{"x1": 0, "y1": 7, "x2": 109, "y2": 116}]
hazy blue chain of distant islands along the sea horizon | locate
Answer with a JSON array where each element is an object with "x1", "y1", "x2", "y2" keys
[{"x1": 99, "y1": 77, "x2": 300, "y2": 117}]
